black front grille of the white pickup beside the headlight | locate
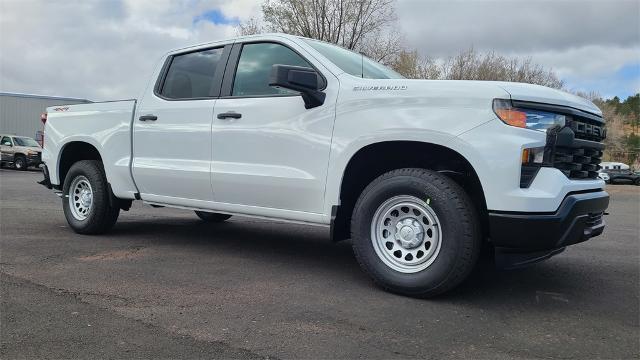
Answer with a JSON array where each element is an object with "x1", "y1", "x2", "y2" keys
[{"x1": 552, "y1": 117, "x2": 606, "y2": 179}]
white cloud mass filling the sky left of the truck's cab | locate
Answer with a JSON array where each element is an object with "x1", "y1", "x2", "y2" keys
[{"x1": 0, "y1": 0, "x2": 255, "y2": 100}]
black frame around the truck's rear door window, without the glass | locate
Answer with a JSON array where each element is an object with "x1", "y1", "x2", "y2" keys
[{"x1": 153, "y1": 44, "x2": 233, "y2": 101}]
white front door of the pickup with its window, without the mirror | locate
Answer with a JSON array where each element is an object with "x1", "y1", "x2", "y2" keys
[{"x1": 211, "y1": 42, "x2": 338, "y2": 214}]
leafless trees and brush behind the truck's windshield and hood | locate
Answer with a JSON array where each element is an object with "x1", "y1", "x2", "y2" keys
[{"x1": 237, "y1": 0, "x2": 563, "y2": 89}]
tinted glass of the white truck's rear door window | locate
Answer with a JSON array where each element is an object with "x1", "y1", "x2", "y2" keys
[{"x1": 160, "y1": 48, "x2": 224, "y2": 99}]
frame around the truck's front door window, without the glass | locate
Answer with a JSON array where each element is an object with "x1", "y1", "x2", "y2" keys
[{"x1": 219, "y1": 40, "x2": 328, "y2": 99}]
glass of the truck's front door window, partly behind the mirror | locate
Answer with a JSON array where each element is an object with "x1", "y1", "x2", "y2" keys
[{"x1": 232, "y1": 43, "x2": 311, "y2": 96}]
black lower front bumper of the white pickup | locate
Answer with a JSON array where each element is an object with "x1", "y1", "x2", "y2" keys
[{"x1": 489, "y1": 190, "x2": 609, "y2": 268}]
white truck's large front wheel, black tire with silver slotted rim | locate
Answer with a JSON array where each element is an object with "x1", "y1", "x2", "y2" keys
[{"x1": 351, "y1": 168, "x2": 480, "y2": 297}]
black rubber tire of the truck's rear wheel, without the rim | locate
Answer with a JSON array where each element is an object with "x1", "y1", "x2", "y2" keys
[{"x1": 62, "y1": 160, "x2": 120, "y2": 235}]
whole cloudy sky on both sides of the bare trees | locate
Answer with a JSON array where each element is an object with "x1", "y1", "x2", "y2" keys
[{"x1": 0, "y1": 0, "x2": 640, "y2": 100}]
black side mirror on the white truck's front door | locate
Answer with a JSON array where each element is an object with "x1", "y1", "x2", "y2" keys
[{"x1": 269, "y1": 64, "x2": 326, "y2": 109}]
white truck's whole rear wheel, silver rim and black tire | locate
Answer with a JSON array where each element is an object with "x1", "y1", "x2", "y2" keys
[{"x1": 62, "y1": 160, "x2": 120, "y2": 234}]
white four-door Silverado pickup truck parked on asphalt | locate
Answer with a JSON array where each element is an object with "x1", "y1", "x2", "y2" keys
[{"x1": 42, "y1": 34, "x2": 609, "y2": 297}]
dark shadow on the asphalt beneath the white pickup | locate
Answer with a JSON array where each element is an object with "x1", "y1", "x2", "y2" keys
[{"x1": 109, "y1": 218, "x2": 599, "y2": 307}]
